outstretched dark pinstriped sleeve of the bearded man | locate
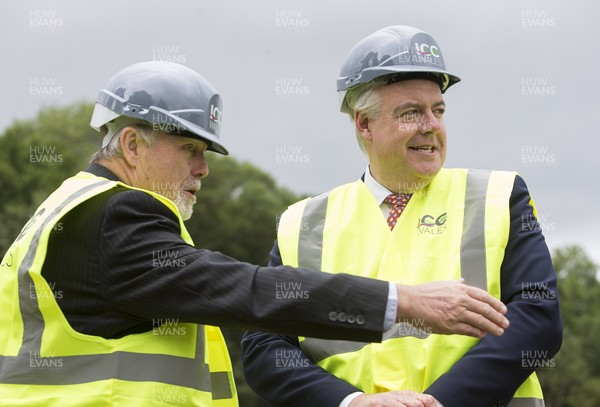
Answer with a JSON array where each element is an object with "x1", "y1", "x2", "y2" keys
[{"x1": 100, "y1": 190, "x2": 388, "y2": 341}]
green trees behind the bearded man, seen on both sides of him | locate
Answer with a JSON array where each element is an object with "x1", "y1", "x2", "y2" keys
[{"x1": 0, "y1": 103, "x2": 300, "y2": 407}]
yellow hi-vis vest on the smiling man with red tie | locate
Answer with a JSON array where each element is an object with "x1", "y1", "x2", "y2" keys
[{"x1": 278, "y1": 169, "x2": 544, "y2": 407}]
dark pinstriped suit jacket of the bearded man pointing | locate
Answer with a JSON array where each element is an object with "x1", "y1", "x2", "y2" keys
[{"x1": 42, "y1": 164, "x2": 389, "y2": 341}]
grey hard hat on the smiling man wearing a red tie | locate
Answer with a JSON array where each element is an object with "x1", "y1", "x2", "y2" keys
[{"x1": 337, "y1": 25, "x2": 460, "y2": 113}]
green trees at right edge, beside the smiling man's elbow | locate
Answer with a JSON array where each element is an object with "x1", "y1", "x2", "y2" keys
[{"x1": 539, "y1": 246, "x2": 600, "y2": 407}]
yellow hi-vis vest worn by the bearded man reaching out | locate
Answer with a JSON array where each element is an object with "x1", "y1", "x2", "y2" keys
[{"x1": 0, "y1": 172, "x2": 238, "y2": 407}]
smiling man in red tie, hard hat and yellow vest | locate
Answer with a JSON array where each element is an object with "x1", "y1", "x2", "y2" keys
[{"x1": 242, "y1": 26, "x2": 562, "y2": 407}]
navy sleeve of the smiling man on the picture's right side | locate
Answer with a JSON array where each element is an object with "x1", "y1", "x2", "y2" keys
[{"x1": 425, "y1": 177, "x2": 562, "y2": 407}]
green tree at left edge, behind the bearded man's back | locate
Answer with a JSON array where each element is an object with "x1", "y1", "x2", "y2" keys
[{"x1": 0, "y1": 104, "x2": 100, "y2": 254}]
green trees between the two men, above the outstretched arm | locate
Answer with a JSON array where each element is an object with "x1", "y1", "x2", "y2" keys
[{"x1": 187, "y1": 154, "x2": 299, "y2": 265}]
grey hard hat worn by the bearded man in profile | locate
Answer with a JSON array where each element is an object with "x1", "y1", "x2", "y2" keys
[{"x1": 90, "y1": 61, "x2": 229, "y2": 155}]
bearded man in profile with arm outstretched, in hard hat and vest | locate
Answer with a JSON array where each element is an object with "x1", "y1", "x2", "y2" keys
[{"x1": 0, "y1": 61, "x2": 508, "y2": 407}]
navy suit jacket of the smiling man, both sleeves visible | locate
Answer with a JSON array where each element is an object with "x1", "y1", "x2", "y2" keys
[{"x1": 242, "y1": 177, "x2": 562, "y2": 407}]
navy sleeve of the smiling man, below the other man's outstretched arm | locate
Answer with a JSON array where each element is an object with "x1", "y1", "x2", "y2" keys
[{"x1": 242, "y1": 242, "x2": 360, "y2": 407}]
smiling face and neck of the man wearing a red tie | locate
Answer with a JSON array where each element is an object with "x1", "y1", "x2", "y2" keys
[{"x1": 355, "y1": 79, "x2": 446, "y2": 192}]
